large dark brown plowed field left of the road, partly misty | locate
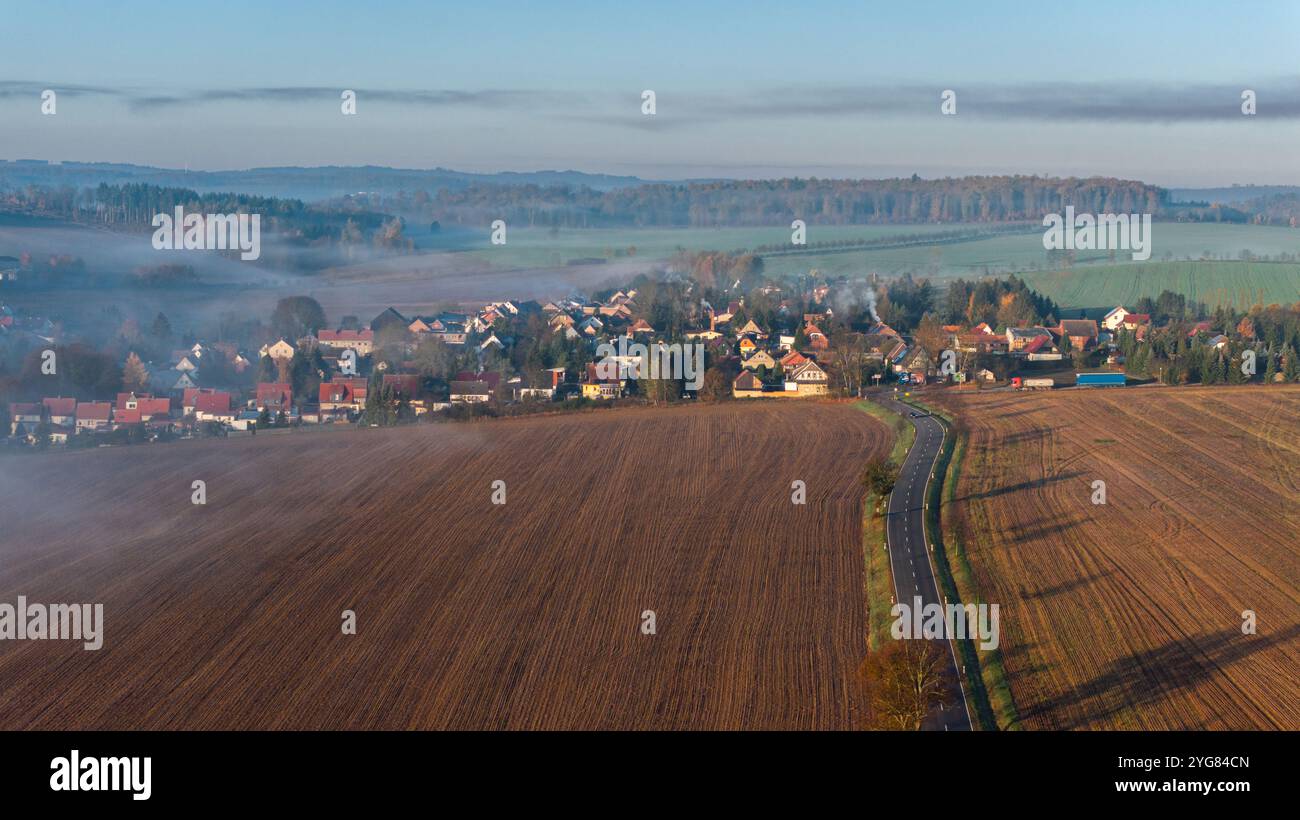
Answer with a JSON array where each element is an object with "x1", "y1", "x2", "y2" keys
[{"x1": 0, "y1": 402, "x2": 891, "y2": 729}]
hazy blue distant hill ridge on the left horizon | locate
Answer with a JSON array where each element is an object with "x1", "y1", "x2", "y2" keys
[{"x1": 0, "y1": 160, "x2": 646, "y2": 201}]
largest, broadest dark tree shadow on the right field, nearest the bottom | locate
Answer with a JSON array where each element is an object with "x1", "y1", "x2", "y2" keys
[{"x1": 1017, "y1": 624, "x2": 1300, "y2": 729}]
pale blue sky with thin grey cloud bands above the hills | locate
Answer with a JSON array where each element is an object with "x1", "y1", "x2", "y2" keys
[{"x1": 0, "y1": 0, "x2": 1300, "y2": 185}]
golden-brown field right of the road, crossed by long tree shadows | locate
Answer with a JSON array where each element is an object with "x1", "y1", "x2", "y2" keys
[{"x1": 945, "y1": 386, "x2": 1300, "y2": 729}]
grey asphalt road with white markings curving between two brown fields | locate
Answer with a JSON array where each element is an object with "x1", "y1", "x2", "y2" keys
[{"x1": 881, "y1": 396, "x2": 971, "y2": 732}]
